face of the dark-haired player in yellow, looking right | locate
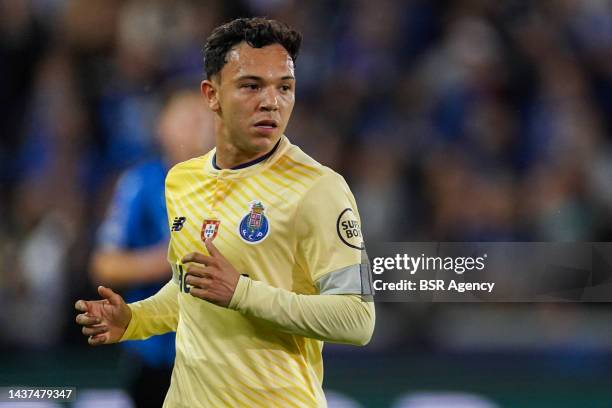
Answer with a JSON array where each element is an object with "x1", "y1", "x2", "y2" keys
[{"x1": 209, "y1": 42, "x2": 295, "y2": 155}]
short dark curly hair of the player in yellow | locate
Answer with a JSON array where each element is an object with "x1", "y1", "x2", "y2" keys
[{"x1": 204, "y1": 17, "x2": 302, "y2": 79}]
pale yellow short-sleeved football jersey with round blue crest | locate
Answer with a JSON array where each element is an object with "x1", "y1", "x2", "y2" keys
[{"x1": 164, "y1": 137, "x2": 363, "y2": 408}]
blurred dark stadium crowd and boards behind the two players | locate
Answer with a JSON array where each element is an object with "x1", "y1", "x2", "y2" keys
[{"x1": 0, "y1": 0, "x2": 612, "y2": 407}]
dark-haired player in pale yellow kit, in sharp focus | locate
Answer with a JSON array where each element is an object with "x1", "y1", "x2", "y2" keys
[{"x1": 75, "y1": 18, "x2": 374, "y2": 407}]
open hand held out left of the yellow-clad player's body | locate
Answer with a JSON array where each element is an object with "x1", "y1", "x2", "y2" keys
[{"x1": 74, "y1": 286, "x2": 132, "y2": 346}]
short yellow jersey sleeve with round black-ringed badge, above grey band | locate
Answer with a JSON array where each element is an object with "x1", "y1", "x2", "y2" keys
[{"x1": 296, "y1": 171, "x2": 364, "y2": 282}]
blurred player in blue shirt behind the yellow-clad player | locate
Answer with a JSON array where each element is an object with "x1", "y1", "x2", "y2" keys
[{"x1": 91, "y1": 91, "x2": 214, "y2": 407}]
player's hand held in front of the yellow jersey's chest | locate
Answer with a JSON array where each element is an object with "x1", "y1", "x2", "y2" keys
[{"x1": 181, "y1": 239, "x2": 240, "y2": 307}]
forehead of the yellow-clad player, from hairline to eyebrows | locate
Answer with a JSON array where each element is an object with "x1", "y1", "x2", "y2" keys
[{"x1": 222, "y1": 42, "x2": 294, "y2": 77}]
